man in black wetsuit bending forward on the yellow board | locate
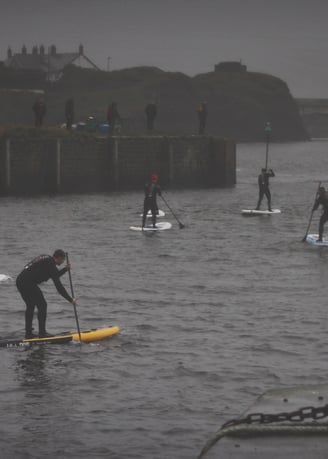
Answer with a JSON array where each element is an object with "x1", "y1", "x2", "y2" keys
[{"x1": 16, "y1": 249, "x2": 76, "y2": 338}]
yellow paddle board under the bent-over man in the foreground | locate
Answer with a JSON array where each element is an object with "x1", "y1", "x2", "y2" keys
[{"x1": 0, "y1": 326, "x2": 120, "y2": 347}]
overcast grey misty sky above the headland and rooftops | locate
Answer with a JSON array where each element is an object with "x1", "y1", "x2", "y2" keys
[{"x1": 0, "y1": 0, "x2": 328, "y2": 98}]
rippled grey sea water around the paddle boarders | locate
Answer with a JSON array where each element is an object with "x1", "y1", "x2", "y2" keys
[{"x1": 0, "y1": 141, "x2": 328, "y2": 459}]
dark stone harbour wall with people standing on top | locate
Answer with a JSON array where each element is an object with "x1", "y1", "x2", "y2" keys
[{"x1": 0, "y1": 135, "x2": 236, "y2": 195}]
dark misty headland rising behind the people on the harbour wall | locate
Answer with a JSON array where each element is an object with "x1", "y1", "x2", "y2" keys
[{"x1": 0, "y1": 66, "x2": 307, "y2": 141}]
